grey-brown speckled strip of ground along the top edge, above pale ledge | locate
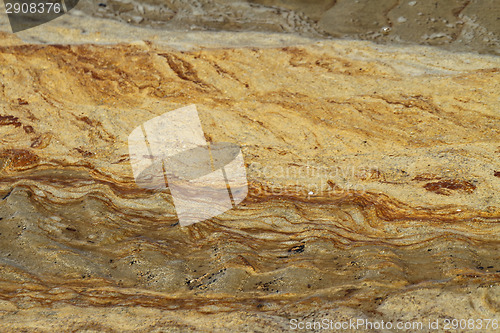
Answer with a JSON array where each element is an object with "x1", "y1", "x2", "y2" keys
[{"x1": 68, "y1": 0, "x2": 500, "y2": 55}]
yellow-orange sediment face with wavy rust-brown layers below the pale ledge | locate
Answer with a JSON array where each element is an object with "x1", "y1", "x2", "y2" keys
[{"x1": 0, "y1": 33, "x2": 500, "y2": 332}]
